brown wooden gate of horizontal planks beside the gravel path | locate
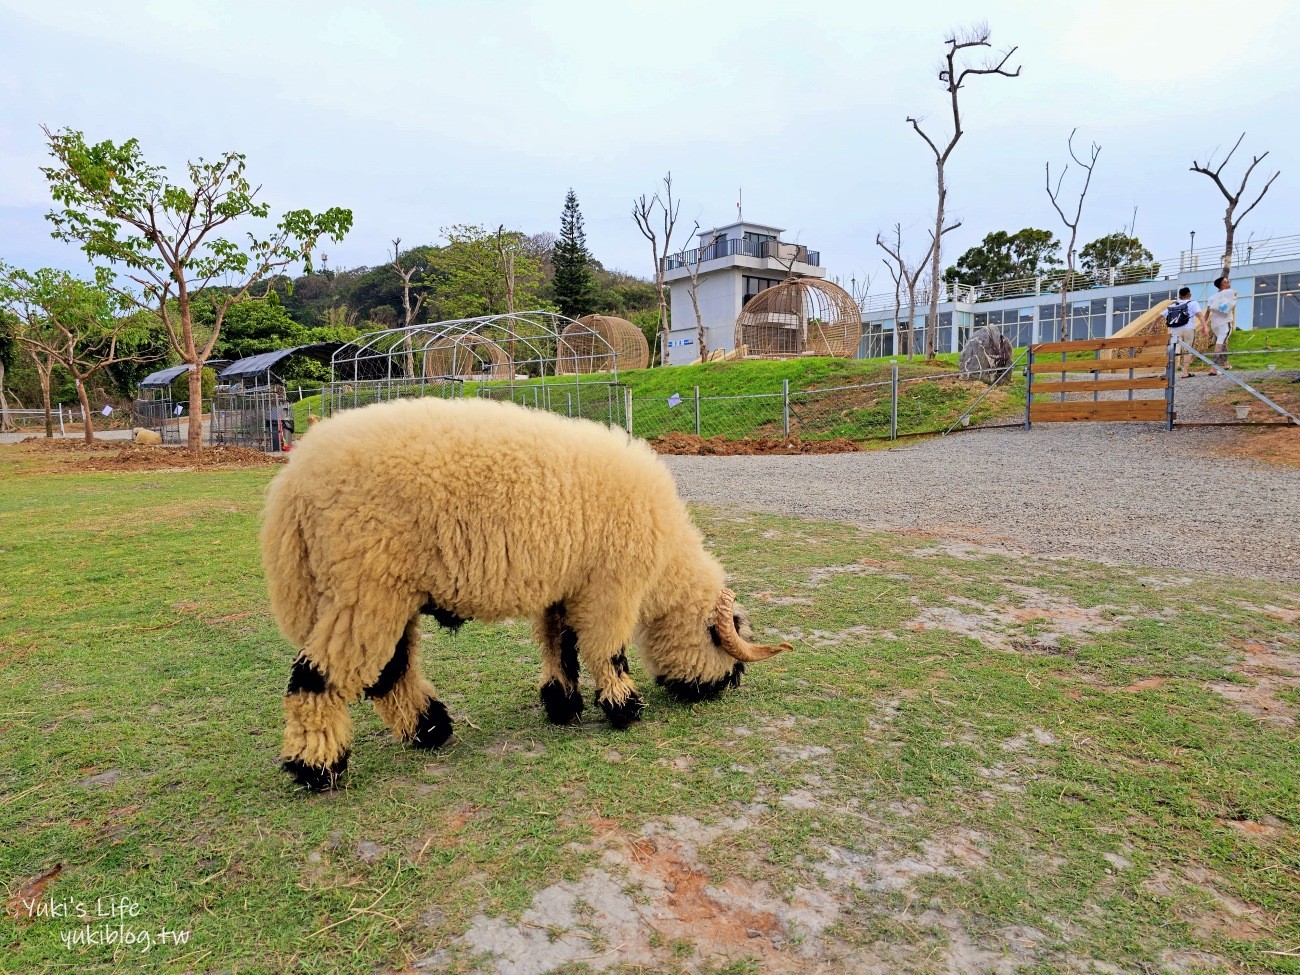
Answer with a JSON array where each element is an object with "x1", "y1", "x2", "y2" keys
[{"x1": 1024, "y1": 335, "x2": 1174, "y2": 429}]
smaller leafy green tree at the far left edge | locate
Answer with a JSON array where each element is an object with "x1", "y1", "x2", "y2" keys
[{"x1": 0, "y1": 265, "x2": 156, "y2": 443}]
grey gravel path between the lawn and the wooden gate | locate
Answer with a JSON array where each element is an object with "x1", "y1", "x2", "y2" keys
[{"x1": 664, "y1": 377, "x2": 1300, "y2": 584}]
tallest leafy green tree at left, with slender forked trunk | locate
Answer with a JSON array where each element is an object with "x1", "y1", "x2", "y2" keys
[{"x1": 42, "y1": 129, "x2": 352, "y2": 450}]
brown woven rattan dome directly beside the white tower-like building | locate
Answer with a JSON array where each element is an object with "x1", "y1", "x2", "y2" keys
[{"x1": 736, "y1": 278, "x2": 862, "y2": 359}]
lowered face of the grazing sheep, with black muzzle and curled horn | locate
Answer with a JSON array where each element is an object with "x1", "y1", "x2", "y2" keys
[{"x1": 637, "y1": 589, "x2": 790, "y2": 701}]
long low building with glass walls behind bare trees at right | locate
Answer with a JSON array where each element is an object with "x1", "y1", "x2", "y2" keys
[{"x1": 858, "y1": 248, "x2": 1300, "y2": 359}]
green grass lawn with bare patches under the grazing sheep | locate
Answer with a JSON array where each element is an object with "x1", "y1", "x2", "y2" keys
[{"x1": 0, "y1": 449, "x2": 1300, "y2": 975}]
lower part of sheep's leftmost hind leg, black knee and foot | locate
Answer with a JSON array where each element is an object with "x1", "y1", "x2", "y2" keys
[{"x1": 281, "y1": 654, "x2": 352, "y2": 792}]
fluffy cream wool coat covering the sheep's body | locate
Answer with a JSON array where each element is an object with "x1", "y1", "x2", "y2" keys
[{"x1": 263, "y1": 399, "x2": 723, "y2": 686}]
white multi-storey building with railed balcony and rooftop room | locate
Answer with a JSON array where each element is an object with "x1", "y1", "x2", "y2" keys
[{"x1": 663, "y1": 222, "x2": 826, "y2": 365}]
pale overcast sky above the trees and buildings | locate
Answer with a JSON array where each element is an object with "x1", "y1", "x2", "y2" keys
[{"x1": 0, "y1": 0, "x2": 1300, "y2": 291}]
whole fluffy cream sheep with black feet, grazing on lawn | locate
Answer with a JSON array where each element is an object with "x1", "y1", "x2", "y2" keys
[{"x1": 261, "y1": 399, "x2": 789, "y2": 790}]
